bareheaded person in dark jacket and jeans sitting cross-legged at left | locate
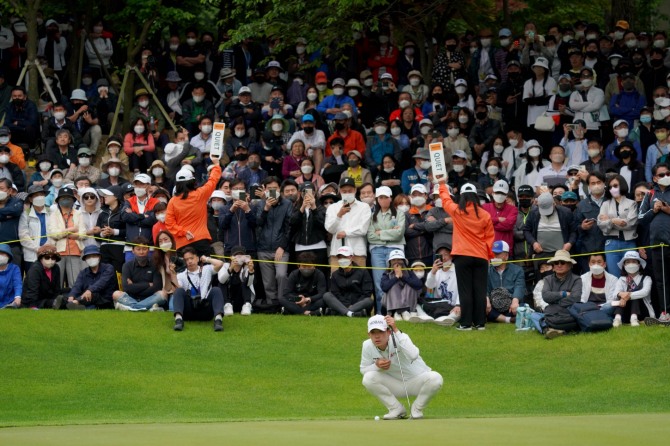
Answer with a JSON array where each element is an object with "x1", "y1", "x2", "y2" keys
[{"x1": 112, "y1": 237, "x2": 168, "y2": 311}]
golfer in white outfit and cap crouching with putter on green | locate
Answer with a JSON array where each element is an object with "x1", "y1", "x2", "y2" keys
[{"x1": 361, "y1": 315, "x2": 442, "y2": 420}]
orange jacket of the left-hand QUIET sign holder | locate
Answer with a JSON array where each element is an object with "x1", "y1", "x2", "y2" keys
[{"x1": 165, "y1": 163, "x2": 221, "y2": 249}]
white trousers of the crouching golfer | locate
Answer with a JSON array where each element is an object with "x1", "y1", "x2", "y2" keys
[{"x1": 363, "y1": 370, "x2": 442, "y2": 411}]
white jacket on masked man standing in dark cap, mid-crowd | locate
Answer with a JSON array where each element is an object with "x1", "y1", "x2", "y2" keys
[{"x1": 324, "y1": 200, "x2": 372, "y2": 256}]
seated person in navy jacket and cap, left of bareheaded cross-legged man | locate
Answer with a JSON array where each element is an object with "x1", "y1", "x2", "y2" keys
[{"x1": 67, "y1": 245, "x2": 119, "y2": 310}]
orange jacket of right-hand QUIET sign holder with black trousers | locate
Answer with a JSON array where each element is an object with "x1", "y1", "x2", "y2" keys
[{"x1": 440, "y1": 184, "x2": 495, "y2": 261}]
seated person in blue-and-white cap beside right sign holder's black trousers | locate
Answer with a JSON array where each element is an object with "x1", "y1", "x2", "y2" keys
[{"x1": 486, "y1": 240, "x2": 526, "y2": 324}]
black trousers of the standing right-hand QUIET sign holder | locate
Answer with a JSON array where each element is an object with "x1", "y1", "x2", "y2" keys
[{"x1": 453, "y1": 256, "x2": 489, "y2": 327}]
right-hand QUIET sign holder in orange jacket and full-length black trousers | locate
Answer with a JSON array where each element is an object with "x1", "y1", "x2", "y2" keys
[{"x1": 439, "y1": 178, "x2": 495, "y2": 331}]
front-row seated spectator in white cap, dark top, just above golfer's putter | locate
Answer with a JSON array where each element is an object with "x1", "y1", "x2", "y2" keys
[{"x1": 381, "y1": 249, "x2": 423, "y2": 321}]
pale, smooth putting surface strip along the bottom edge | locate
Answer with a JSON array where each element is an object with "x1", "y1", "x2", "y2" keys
[{"x1": 0, "y1": 414, "x2": 670, "y2": 446}]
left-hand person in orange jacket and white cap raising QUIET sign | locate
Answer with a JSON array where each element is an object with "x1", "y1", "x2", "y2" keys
[{"x1": 165, "y1": 157, "x2": 221, "y2": 255}]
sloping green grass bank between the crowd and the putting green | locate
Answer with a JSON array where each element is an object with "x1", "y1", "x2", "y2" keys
[{"x1": 0, "y1": 310, "x2": 670, "y2": 426}]
